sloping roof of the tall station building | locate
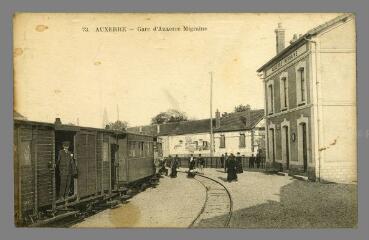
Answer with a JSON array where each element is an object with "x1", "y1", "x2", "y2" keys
[{"x1": 257, "y1": 13, "x2": 353, "y2": 72}]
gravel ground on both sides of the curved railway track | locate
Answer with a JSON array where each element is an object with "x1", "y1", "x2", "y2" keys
[{"x1": 70, "y1": 169, "x2": 357, "y2": 228}]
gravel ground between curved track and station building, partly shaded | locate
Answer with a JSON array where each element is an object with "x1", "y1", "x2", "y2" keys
[{"x1": 201, "y1": 169, "x2": 357, "y2": 228}]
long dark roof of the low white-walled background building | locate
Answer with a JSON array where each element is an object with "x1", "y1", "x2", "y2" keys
[{"x1": 127, "y1": 109, "x2": 264, "y2": 136}]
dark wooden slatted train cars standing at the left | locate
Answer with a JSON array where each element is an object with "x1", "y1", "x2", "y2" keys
[{"x1": 14, "y1": 120, "x2": 155, "y2": 226}]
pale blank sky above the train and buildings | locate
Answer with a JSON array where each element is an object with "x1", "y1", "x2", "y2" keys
[{"x1": 14, "y1": 13, "x2": 338, "y2": 127}]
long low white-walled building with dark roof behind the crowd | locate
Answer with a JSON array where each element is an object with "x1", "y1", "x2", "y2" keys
[{"x1": 128, "y1": 109, "x2": 264, "y2": 157}]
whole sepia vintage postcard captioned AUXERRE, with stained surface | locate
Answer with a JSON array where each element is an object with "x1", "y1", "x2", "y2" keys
[{"x1": 13, "y1": 13, "x2": 358, "y2": 229}]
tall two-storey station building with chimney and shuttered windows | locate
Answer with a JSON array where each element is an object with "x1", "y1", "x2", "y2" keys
[{"x1": 257, "y1": 14, "x2": 357, "y2": 182}]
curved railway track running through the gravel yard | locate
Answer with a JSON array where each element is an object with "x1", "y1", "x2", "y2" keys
[{"x1": 189, "y1": 175, "x2": 233, "y2": 228}]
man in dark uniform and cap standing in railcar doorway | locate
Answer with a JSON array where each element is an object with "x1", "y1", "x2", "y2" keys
[{"x1": 56, "y1": 141, "x2": 77, "y2": 198}]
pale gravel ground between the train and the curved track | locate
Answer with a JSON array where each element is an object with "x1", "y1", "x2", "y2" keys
[{"x1": 73, "y1": 173, "x2": 205, "y2": 228}]
